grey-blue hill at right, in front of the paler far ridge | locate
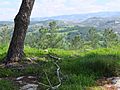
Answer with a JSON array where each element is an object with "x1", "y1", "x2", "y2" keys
[{"x1": 80, "y1": 17, "x2": 120, "y2": 32}]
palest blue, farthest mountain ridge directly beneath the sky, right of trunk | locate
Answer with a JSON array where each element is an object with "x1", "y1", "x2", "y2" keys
[{"x1": 31, "y1": 12, "x2": 120, "y2": 22}]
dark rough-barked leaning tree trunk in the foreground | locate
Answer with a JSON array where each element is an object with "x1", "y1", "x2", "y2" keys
[{"x1": 5, "y1": 0, "x2": 35, "y2": 64}]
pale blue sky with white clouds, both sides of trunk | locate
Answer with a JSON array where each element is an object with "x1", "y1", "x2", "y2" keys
[{"x1": 0, "y1": 0, "x2": 120, "y2": 20}]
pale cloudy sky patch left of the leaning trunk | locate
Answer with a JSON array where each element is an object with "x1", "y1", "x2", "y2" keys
[{"x1": 0, "y1": 0, "x2": 21, "y2": 20}]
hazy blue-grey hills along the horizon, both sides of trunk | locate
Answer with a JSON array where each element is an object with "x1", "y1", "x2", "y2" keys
[{"x1": 0, "y1": 12, "x2": 120, "y2": 32}]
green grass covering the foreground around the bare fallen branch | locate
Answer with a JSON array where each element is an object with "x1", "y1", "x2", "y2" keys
[{"x1": 0, "y1": 46, "x2": 120, "y2": 90}]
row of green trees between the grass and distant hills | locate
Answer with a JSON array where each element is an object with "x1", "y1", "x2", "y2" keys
[{"x1": 0, "y1": 21, "x2": 120, "y2": 50}]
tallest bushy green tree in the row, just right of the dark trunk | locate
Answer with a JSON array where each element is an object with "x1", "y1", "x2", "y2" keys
[{"x1": 27, "y1": 21, "x2": 64, "y2": 49}]
